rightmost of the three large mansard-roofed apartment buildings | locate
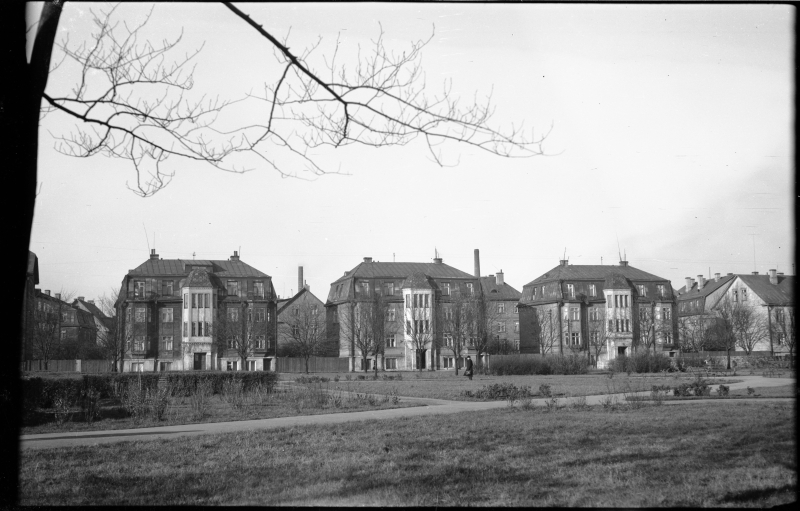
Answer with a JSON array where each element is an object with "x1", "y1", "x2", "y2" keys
[{"x1": 519, "y1": 260, "x2": 677, "y2": 367}]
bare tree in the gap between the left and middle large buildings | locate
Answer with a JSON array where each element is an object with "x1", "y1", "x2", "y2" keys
[{"x1": 280, "y1": 297, "x2": 329, "y2": 374}]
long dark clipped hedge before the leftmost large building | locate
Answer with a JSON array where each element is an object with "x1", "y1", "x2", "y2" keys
[{"x1": 22, "y1": 371, "x2": 278, "y2": 409}]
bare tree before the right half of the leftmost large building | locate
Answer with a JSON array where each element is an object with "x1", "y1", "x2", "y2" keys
[{"x1": 212, "y1": 302, "x2": 269, "y2": 369}]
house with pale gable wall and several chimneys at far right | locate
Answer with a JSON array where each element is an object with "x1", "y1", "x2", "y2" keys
[{"x1": 677, "y1": 269, "x2": 795, "y2": 354}]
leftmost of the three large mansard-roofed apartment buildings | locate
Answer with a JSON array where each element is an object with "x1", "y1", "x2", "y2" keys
[{"x1": 115, "y1": 250, "x2": 277, "y2": 371}]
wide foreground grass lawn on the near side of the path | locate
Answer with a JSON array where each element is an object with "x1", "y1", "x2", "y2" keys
[{"x1": 19, "y1": 402, "x2": 797, "y2": 507}]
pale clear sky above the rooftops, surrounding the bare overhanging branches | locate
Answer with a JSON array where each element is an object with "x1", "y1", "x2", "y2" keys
[{"x1": 28, "y1": 2, "x2": 795, "y2": 300}]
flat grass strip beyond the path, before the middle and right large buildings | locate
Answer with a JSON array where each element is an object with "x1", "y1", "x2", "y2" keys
[{"x1": 281, "y1": 371, "x2": 741, "y2": 401}]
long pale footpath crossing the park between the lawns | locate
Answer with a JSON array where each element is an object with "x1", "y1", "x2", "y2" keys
[{"x1": 20, "y1": 376, "x2": 795, "y2": 449}]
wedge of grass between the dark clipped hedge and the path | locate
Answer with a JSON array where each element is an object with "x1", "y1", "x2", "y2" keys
[{"x1": 20, "y1": 383, "x2": 417, "y2": 435}]
